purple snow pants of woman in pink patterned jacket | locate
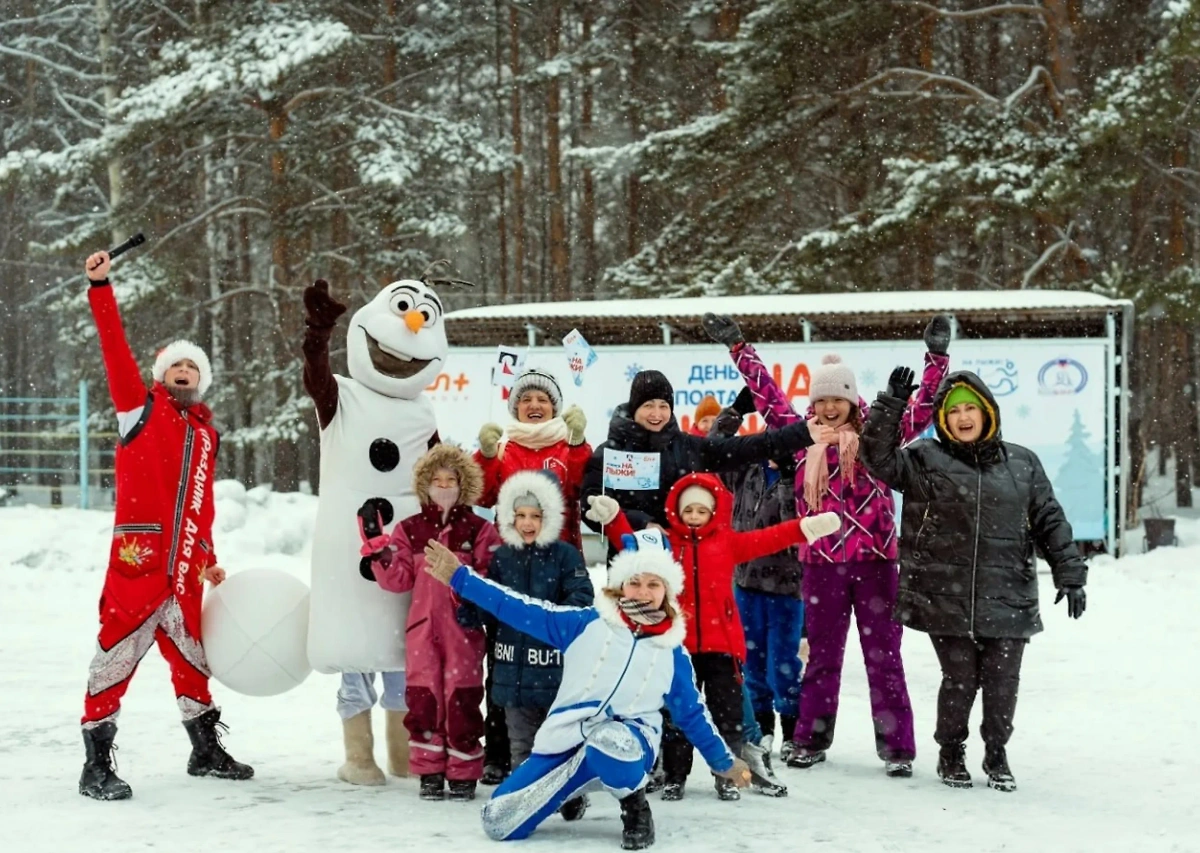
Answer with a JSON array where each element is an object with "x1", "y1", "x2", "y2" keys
[{"x1": 796, "y1": 560, "x2": 917, "y2": 761}]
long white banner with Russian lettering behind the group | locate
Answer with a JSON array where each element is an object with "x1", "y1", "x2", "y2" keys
[{"x1": 428, "y1": 338, "x2": 1111, "y2": 540}]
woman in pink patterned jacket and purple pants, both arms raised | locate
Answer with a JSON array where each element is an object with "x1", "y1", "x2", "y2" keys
[{"x1": 704, "y1": 314, "x2": 950, "y2": 777}]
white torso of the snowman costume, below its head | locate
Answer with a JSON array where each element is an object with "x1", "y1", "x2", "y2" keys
[{"x1": 308, "y1": 377, "x2": 437, "y2": 673}]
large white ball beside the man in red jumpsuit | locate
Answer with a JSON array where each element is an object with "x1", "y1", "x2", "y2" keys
[{"x1": 200, "y1": 569, "x2": 312, "y2": 696}]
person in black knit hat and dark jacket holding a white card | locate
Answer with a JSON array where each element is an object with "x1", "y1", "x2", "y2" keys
[{"x1": 582, "y1": 371, "x2": 812, "y2": 547}]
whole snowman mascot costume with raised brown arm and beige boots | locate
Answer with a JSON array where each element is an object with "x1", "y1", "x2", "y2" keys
[{"x1": 304, "y1": 275, "x2": 449, "y2": 785}]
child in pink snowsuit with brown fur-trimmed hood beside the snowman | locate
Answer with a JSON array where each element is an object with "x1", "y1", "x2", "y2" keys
[{"x1": 362, "y1": 444, "x2": 500, "y2": 800}]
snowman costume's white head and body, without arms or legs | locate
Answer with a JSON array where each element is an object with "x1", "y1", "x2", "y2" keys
[{"x1": 308, "y1": 280, "x2": 449, "y2": 673}]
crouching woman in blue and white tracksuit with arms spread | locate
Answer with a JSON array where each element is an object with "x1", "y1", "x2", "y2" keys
[{"x1": 425, "y1": 529, "x2": 750, "y2": 849}]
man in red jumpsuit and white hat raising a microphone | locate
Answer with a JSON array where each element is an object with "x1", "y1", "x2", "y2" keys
[{"x1": 79, "y1": 252, "x2": 254, "y2": 800}]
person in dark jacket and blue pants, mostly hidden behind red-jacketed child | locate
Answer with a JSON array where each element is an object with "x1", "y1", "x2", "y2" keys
[{"x1": 713, "y1": 388, "x2": 804, "y2": 762}]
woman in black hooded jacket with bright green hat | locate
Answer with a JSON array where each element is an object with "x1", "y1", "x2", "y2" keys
[{"x1": 863, "y1": 367, "x2": 1087, "y2": 791}]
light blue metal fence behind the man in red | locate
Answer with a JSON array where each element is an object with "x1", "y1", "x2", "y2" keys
[{"x1": 0, "y1": 380, "x2": 115, "y2": 510}]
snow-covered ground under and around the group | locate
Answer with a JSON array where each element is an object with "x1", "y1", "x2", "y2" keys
[{"x1": 0, "y1": 483, "x2": 1200, "y2": 853}]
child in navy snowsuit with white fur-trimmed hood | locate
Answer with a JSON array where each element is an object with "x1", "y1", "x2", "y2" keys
[{"x1": 475, "y1": 471, "x2": 595, "y2": 821}]
